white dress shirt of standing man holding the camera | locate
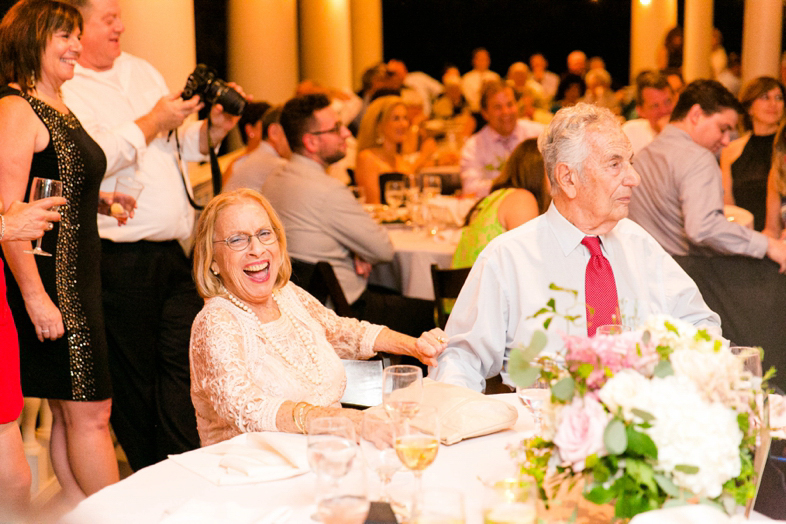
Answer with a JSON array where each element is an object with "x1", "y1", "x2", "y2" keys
[{"x1": 62, "y1": 53, "x2": 207, "y2": 242}]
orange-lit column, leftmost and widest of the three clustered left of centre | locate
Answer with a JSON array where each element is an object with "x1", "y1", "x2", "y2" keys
[{"x1": 227, "y1": 0, "x2": 298, "y2": 104}]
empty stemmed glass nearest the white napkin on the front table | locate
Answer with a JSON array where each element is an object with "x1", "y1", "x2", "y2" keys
[{"x1": 307, "y1": 417, "x2": 360, "y2": 521}]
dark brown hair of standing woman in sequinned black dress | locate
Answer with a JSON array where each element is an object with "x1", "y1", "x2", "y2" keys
[{"x1": 0, "y1": 0, "x2": 82, "y2": 94}]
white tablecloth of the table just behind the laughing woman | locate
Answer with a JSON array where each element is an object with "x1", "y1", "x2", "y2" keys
[{"x1": 369, "y1": 227, "x2": 461, "y2": 300}]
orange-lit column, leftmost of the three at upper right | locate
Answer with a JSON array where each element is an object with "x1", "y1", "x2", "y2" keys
[{"x1": 630, "y1": 0, "x2": 677, "y2": 83}]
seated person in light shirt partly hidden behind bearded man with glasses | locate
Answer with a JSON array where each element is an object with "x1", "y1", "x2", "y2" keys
[{"x1": 224, "y1": 106, "x2": 292, "y2": 191}]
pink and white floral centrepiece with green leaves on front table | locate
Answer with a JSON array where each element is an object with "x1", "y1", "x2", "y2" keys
[{"x1": 509, "y1": 316, "x2": 770, "y2": 519}]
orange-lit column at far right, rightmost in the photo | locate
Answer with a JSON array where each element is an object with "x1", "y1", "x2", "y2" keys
[{"x1": 742, "y1": 0, "x2": 783, "y2": 85}]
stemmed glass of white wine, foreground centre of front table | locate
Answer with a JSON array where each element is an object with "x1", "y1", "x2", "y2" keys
[{"x1": 393, "y1": 406, "x2": 440, "y2": 515}]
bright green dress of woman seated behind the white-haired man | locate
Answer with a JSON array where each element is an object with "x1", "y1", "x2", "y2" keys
[{"x1": 451, "y1": 188, "x2": 515, "y2": 268}]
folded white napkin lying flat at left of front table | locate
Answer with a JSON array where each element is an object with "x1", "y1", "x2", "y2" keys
[{"x1": 169, "y1": 432, "x2": 309, "y2": 486}]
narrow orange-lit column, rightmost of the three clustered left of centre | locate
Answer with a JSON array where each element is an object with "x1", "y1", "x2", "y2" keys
[{"x1": 350, "y1": 0, "x2": 384, "y2": 91}]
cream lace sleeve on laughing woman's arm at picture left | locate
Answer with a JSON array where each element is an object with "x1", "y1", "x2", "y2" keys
[{"x1": 190, "y1": 306, "x2": 286, "y2": 432}]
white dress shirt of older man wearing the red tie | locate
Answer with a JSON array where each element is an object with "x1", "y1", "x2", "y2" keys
[{"x1": 429, "y1": 203, "x2": 720, "y2": 391}]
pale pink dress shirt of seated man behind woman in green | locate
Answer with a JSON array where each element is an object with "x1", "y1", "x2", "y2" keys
[{"x1": 461, "y1": 119, "x2": 544, "y2": 198}]
